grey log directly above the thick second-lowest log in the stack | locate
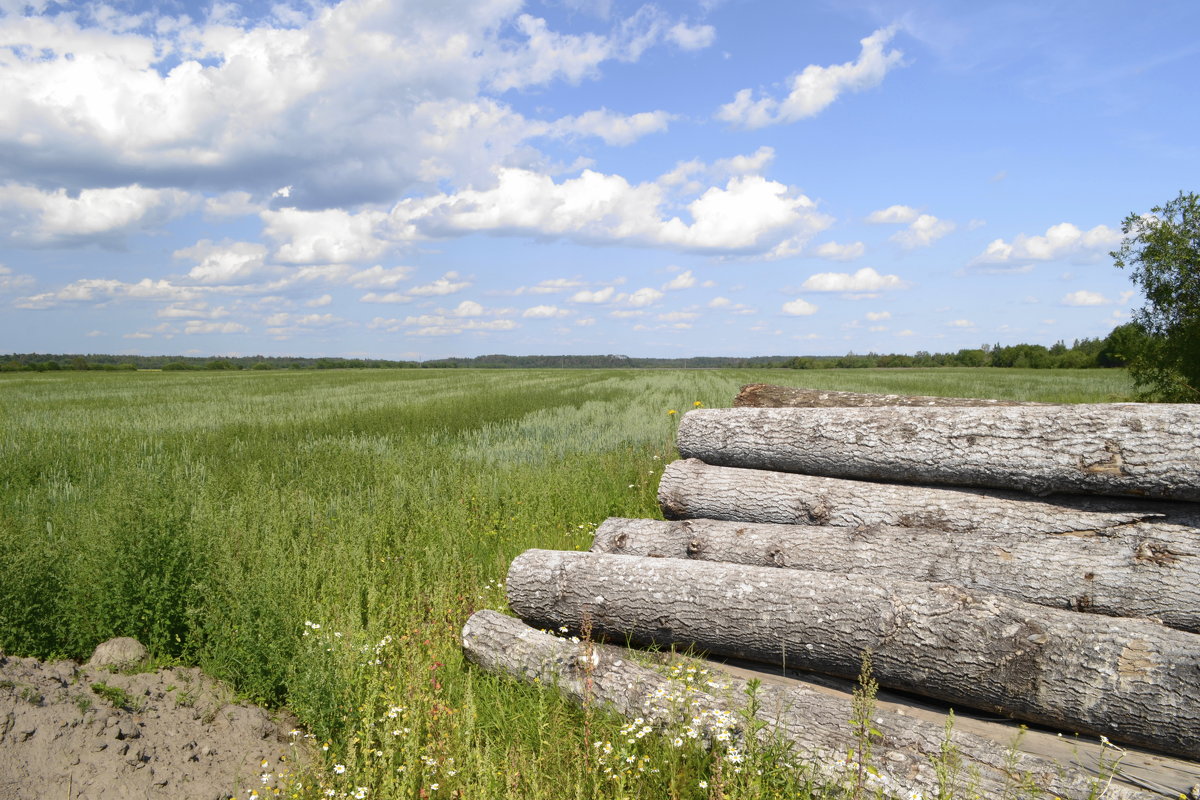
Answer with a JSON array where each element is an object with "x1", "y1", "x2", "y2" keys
[{"x1": 592, "y1": 518, "x2": 1200, "y2": 632}]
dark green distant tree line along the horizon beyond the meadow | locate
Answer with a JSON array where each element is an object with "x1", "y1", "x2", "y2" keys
[{"x1": 0, "y1": 323, "x2": 1147, "y2": 372}]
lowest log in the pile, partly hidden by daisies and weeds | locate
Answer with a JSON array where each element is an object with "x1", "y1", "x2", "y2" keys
[{"x1": 462, "y1": 610, "x2": 1161, "y2": 800}]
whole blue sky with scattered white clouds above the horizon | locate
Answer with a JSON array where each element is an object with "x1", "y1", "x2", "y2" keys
[{"x1": 0, "y1": 0, "x2": 1200, "y2": 359}]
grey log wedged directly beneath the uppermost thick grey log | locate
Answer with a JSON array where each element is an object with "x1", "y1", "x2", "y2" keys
[{"x1": 659, "y1": 459, "x2": 1200, "y2": 535}]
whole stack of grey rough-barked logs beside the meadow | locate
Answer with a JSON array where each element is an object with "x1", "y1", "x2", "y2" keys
[{"x1": 463, "y1": 385, "x2": 1200, "y2": 798}]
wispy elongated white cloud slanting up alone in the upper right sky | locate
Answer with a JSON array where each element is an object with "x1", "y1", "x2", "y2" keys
[{"x1": 716, "y1": 28, "x2": 904, "y2": 128}]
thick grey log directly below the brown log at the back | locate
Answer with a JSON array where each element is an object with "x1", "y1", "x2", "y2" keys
[{"x1": 677, "y1": 404, "x2": 1200, "y2": 501}]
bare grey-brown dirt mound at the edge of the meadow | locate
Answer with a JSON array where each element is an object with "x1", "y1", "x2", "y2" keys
[{"x1": 0, "y1": 645, "x2": 311, "y2": 800}]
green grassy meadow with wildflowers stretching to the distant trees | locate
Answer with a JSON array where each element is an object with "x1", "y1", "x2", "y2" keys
[{"x1": 0, "y1": 368, "x2": 1133, "y2": 800}]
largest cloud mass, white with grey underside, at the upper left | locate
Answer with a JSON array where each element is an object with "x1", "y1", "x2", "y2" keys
[{"x1": 0, "y1": 0, "x2": 713, "y2": 206}]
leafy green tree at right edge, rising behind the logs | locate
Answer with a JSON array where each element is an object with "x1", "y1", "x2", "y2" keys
[{"x1": 1110, "y1": 192, "x2": 1200, "y2": 403}]
